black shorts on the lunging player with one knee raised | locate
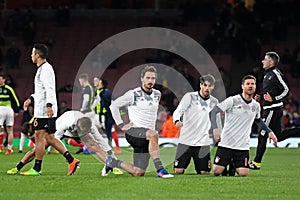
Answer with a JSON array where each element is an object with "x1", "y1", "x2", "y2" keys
[{"x1": 125, "y1": 128, "x2": 150, "y2": 170}]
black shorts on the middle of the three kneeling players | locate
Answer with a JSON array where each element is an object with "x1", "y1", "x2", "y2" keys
[{"x1": 174, "y1": 143, "x2": 211, "y2": 174}]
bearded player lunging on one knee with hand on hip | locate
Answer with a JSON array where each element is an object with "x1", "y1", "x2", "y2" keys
[{"x1": 106, "y1": 66, "x2": 174, "y2": 178}]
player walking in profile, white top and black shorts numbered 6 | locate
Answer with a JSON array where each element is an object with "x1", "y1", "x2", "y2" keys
[{"x1": 21, "y1": 43, "x2": 80, "y2": 176}]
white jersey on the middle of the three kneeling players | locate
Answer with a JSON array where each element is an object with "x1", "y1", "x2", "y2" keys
[{"x1": 173, "y1": 92, "x2": 219, "y2": 146}]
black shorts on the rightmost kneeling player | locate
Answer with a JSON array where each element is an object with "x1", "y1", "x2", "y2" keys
[{"x1": 214, "y1": 147, "x2": 250, "y2": 168}]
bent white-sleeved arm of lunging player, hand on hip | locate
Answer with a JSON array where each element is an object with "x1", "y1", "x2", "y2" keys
[{"x1": 109, "y1": 90, "x2": 133, "y2": 128}]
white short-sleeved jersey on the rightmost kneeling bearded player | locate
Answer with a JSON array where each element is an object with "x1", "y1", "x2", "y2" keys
[{"x1": 218, "y1": 94, "x2": 260, "y2": 150}]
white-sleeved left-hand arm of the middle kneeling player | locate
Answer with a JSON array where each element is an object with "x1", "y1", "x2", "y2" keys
[{"x1": 173, "y1": 93, "x2": 191, "y2": 128}]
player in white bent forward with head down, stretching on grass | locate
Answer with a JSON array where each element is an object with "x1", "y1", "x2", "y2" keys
[{"x1": 7, "y1": 111, "x2": 122, "y2": 176}]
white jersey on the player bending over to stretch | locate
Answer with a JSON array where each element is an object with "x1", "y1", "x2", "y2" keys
[{"x1": 55, "y1": 110, "x2": 111, "y2": 152}]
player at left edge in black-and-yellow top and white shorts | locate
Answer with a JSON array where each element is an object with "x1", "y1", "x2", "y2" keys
[{"x1": 0, "y1": 73, "x2": 20, "y2": 155}]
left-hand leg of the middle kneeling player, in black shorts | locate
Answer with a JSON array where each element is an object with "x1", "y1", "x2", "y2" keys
[{"x1": 174, "y1": 143, "x2": 192, "y2": 174}]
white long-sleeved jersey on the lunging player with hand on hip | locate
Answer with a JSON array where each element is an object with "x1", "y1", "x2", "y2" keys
[{"x1": 110, "y1": 87, "x2": 161, "y2": 130}]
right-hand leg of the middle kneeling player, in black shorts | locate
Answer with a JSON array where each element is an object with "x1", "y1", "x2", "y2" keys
[{"x1": 191, "y1": 146, "x2": 211, "y2": 174}]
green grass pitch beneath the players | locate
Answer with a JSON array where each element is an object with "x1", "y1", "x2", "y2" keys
[{"x1": 0, "y1": 147, "x2": 300, "y2": 200}]
